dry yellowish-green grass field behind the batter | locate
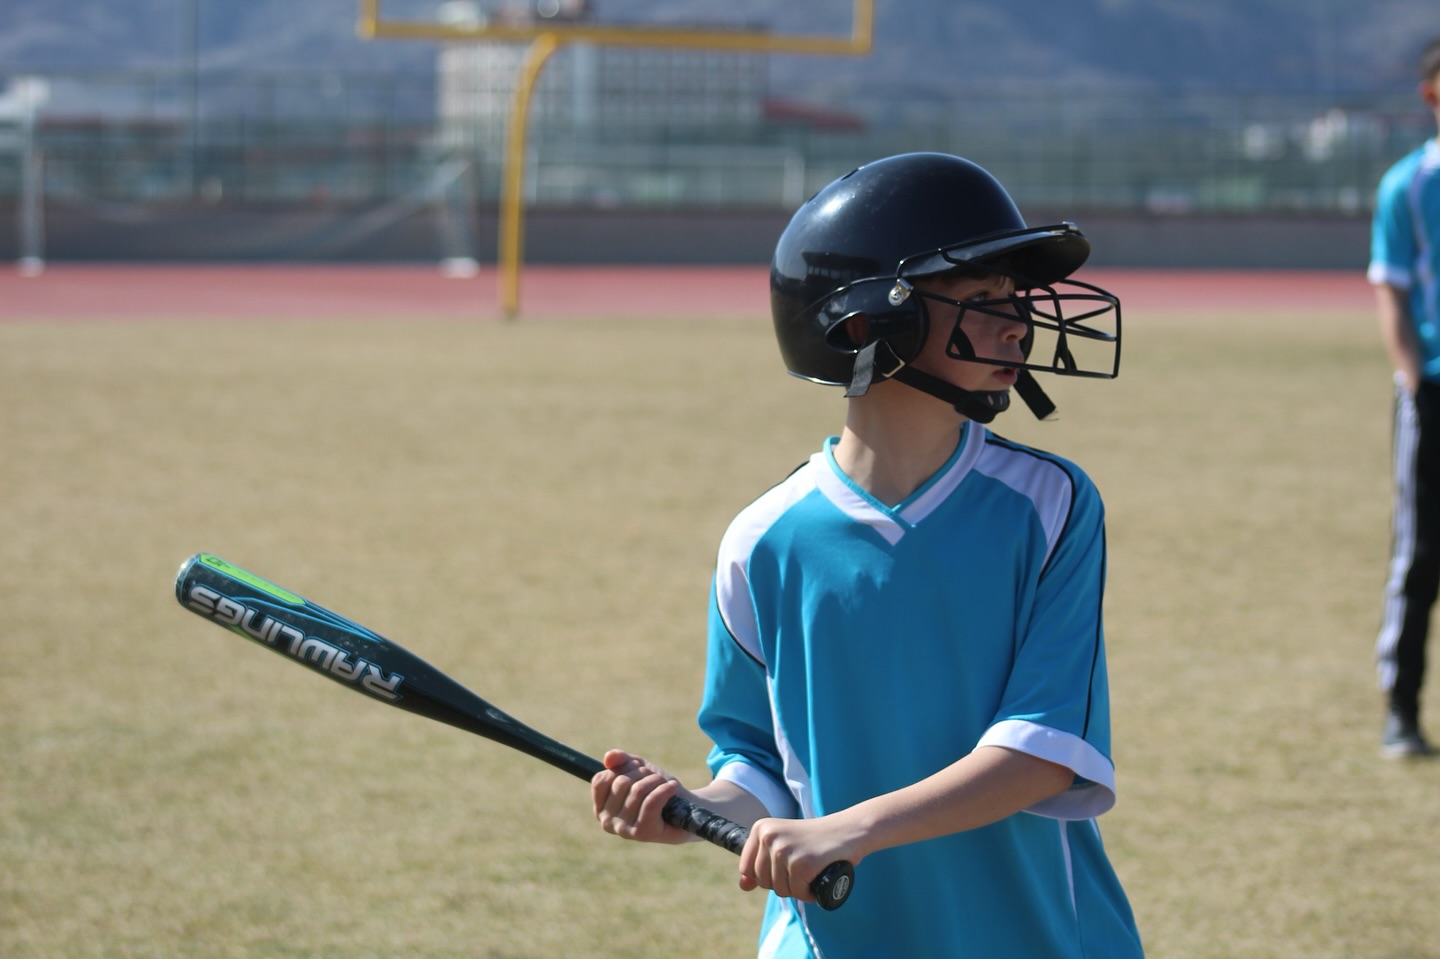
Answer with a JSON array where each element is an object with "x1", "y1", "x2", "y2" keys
[{"x1": 0, "y1": 272, "x2": 1440, "y2": 959}]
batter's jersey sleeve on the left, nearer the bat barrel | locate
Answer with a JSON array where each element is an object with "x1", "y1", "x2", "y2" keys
[{"x1": 698, "y1": 566, "x2": 798, "y2": 818}]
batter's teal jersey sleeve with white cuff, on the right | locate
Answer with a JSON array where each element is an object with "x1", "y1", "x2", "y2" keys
[{"x1": 979, "y1": 471, "x2": 1115, "y2": 819}]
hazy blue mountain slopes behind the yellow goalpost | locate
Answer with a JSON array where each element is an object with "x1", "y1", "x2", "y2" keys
[{"x1": 0, "y1": 0, "x2": 1440, "y2": 111}]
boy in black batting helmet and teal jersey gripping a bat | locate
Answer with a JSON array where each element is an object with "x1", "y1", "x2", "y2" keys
[{"x1": 592, "y1": 154, "x2": 1142, "y2": 959}]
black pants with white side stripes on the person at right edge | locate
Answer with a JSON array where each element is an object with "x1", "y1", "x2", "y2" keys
[{"x1": 1375, "y1": 380, "x2": 1440, "y2": 717}]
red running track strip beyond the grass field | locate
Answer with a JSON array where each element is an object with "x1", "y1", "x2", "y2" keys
[{"x1": 0, "y1": 264, "x2": 1372, "y2": 320}]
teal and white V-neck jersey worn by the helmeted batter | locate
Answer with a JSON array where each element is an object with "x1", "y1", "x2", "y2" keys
[{"x1": 700, "y1": 422, "x2": 1142, "y2": 959}]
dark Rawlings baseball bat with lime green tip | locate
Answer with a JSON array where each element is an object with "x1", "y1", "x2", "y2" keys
[{"x1": 176, "y1": 553, "x2": 854, "y2": 909}]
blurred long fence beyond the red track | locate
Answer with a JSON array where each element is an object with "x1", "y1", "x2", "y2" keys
[{"x1": 0, "y1": 72, "x2": 1434, "y2": 213}]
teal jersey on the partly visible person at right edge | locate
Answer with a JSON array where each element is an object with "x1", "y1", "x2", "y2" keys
[{"x1": 1367, "y1": 140, "x2": 1440, "y2": 380}]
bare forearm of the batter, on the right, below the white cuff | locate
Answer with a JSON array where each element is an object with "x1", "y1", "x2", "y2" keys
[{"x1": 837, "y1": 746, "x2": 1074, "y2": 855}]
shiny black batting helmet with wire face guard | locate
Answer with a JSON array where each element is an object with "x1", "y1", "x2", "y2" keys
[{"x1": 770, "y1": 153, "x2": 1119, "y2": 422}]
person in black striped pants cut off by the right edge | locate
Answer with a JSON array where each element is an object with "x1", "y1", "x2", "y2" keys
[{"x1": 1367, "y1": 37, "x2": 1440, "y2": 757}]
